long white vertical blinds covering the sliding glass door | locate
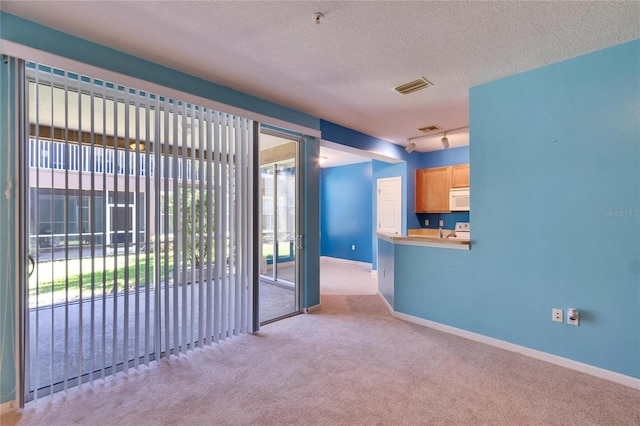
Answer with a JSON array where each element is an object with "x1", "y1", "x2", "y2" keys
[{"x1": 23, "y1": 63, "x2": 255, "y2": 400}]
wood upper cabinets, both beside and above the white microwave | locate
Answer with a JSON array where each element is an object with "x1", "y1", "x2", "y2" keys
[{"x1": 414, "y1": 164, "x2": 469, "y2": 213}]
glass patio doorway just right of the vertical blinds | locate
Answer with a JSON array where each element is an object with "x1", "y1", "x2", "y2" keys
[{"x1": 260, "y1": 130, "x2": 301, "y2": 323}]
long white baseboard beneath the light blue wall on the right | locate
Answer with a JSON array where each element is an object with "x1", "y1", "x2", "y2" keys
[{"x1": 392, "y1": 310, "x2": 640, "y2": 390}]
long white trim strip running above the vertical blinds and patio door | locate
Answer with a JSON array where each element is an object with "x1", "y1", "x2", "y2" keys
[{"x1": 0, "y1": 39, "x2": 321, "y2": 138}]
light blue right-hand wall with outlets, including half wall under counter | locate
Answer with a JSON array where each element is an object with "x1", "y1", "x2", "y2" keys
[{"x1": 394, "y1": 40, "x2": 640, "y2": 378}]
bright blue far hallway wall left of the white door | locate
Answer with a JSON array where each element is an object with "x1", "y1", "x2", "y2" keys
[{"x1": 320, "y1": 161, "x2": 373, "y2": 263}]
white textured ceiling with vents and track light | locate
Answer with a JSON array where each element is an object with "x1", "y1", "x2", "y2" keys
[{"x1": 0, "y1": 0, "x2": 640, "y2": 158}]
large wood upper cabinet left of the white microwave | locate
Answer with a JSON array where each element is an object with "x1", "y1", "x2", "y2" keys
[{"x1": 415, "y1": 167, "x2": 451, "y2": 213}]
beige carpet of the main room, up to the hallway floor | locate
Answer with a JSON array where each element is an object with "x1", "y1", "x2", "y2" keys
[{"x1": 2, "y1": 295, "x2": 640, "y2": 426}]
